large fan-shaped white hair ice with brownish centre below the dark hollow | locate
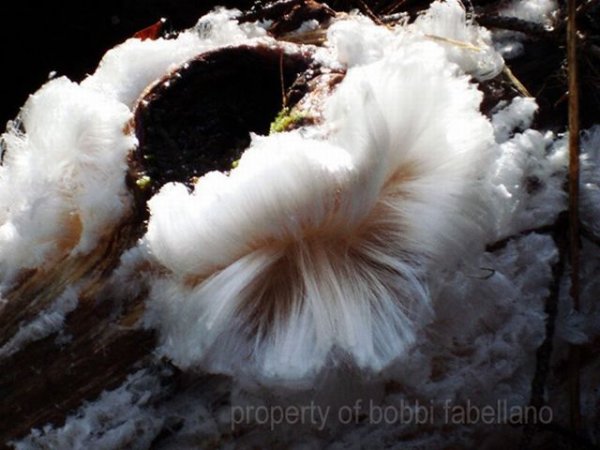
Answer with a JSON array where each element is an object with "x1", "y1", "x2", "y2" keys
[{"x1": 146, "y1": 36, "x2": 493, "y2": 380}]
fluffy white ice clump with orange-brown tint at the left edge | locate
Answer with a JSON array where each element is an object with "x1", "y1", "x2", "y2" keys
[{"x1": 0, "y1": 78, "x2": 135, "y2": 277}]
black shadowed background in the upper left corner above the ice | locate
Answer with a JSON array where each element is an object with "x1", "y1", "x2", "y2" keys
[{"x1": 0, "y1": 0, "x2": 254, "y2": 126}]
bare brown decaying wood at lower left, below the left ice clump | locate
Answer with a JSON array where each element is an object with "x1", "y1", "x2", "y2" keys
[{"x1": 0, "y1": 192, "x2": 154, "y2": 445}]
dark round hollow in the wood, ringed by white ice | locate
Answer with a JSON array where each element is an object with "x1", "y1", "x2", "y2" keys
[{"x1": 129, "y1": 46, "x2": 311, "y2": 192}]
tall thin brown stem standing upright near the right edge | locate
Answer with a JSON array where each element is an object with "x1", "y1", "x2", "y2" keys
[{"x1": 567, "y1": 0, "x2": 581, "y2": 431}]
